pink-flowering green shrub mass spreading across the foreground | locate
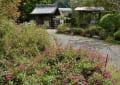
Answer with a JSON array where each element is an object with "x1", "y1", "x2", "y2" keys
[{"x1": 0, "y1": 43, "x2": 118, "y2": 85}]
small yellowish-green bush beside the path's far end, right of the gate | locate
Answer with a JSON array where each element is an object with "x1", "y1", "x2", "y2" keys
[{"x1": 57, "y1": 23, "x2": 70, "y2": 33}]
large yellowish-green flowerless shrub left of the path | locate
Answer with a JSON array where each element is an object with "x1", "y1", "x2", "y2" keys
[{"x1": 0, "y1": 21, "x2": 50, "y2": 58}]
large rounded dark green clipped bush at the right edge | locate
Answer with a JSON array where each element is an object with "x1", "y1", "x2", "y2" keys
[{"x1": 100, "y1": 14, "x2": 120, "y2": 32}]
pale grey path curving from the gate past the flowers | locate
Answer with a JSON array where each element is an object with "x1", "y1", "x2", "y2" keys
[{"x1": 48, "y1": 30, "x2": 120, "y2": 68}]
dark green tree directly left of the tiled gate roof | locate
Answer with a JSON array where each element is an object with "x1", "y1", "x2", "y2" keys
[{"x1": 19, "y1": 0, "x2": 51, "y2": 21}]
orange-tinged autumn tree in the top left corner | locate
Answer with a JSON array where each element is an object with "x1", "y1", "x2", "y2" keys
[{"x1": 0, "y1": 0, "x2": 21, "y2": 19}]
